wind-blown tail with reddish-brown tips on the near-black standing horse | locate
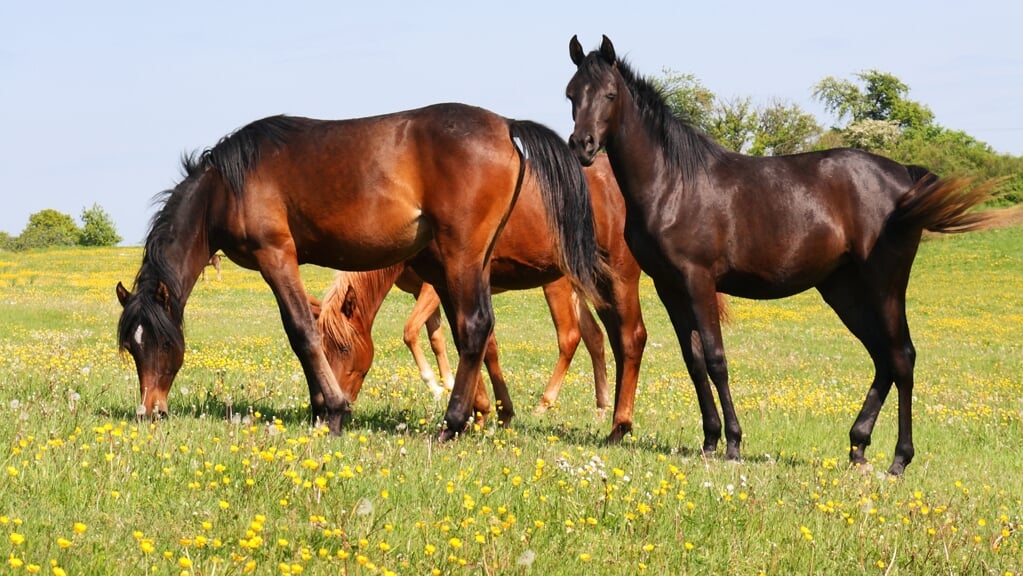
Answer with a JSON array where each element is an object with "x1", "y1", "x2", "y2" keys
[{"x1": 889, "y1": 166, "x2": 1000, "y2": 233}]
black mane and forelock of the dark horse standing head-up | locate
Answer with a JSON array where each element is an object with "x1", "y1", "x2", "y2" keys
[{"x1": 579, "y1": 50, "x2": 727, "y2": 184}]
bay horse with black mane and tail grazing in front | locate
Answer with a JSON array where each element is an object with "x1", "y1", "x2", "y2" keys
[{"x1": 117, "y1": 104, "x2": 607, "y2": 439}]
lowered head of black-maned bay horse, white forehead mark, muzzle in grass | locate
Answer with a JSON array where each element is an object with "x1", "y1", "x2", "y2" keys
[{"x1": 117, "y1": 282, "x2": 185, "y2": 416}]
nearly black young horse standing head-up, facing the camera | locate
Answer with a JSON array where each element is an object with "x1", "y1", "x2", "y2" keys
[{"x1": 567, "y1": 37, "x2": 990, "y2": 474}]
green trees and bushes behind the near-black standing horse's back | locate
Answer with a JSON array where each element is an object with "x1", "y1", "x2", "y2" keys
[{"x1": 654, "y1": 70, "x2": 1023, "y2": 206}]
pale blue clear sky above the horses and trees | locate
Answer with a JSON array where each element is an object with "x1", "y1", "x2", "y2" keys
[{"x1": 6, "y1": 0, "x2": 1023, "y2": 245}]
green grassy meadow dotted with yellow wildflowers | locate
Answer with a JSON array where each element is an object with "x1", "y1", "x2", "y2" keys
[{"x1": 0, "y1": 226, "x2": 1023, "y2": 576}]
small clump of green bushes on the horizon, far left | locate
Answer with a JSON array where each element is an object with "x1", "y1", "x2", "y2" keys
[{"x1": 0, "y1": 204, "x2": 121, "y2": 252}]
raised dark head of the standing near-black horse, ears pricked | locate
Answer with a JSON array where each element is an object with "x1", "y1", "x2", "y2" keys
[{"x1": 565, "y1": 36, "x2": 626, "y2": 166}]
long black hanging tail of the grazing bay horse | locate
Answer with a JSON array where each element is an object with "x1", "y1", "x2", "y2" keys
[{"x1": 508, "y1": 120, "x2": 611, "y2": 304}]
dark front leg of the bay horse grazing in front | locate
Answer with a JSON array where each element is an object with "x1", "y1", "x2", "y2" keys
[{"x1": 256, "y1": 249, "x2": 351, "y2": 434}]
